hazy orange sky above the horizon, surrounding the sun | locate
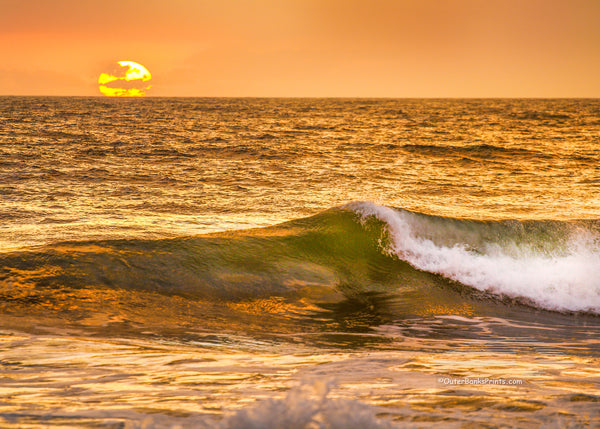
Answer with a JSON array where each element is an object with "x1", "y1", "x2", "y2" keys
[{"x1": 0, "y1": 0, "x2": 600, "y2": 97}]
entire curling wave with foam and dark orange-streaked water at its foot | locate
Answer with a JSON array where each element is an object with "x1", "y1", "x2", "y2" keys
[{"x1": 0, "y1": 203, "x2": 600, "y2": 338}]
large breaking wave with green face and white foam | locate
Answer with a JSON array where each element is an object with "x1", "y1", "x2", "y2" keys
[{"x1": 0, "y1": 202, "x2": 600, "y2": 322}]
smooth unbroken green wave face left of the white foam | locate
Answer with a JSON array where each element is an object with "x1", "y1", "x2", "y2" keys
[{"x1": 0, "y1": 209, "x2": 408, "y2": 301}]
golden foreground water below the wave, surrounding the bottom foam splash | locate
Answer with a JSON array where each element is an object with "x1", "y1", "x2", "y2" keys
[{"x1": 0, "y1": 334, "x2": 600, "y2": 428}]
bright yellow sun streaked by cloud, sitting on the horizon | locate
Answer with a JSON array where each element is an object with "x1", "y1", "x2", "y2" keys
[{"x1": 98, "y1": 61, "x2": 152, "y2": 97}]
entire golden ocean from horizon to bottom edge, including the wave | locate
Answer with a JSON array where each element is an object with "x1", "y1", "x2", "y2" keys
[{"x1": 0, "y1": 97, "x2": 600, "y2": 429}]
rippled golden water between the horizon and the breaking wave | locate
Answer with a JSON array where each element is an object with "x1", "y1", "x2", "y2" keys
[{"x1": 0, "y1": 97, "x2": 600, "y2": 248}]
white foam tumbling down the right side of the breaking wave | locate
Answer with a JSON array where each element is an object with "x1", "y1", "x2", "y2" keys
[{"x1": 347, "y1": 202, "x2": 600, "y2": 314}]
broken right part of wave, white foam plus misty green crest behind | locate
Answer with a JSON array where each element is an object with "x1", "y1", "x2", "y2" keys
[{"x1": 347, "y1": 202, "x2": 600, "y2": 313}]
